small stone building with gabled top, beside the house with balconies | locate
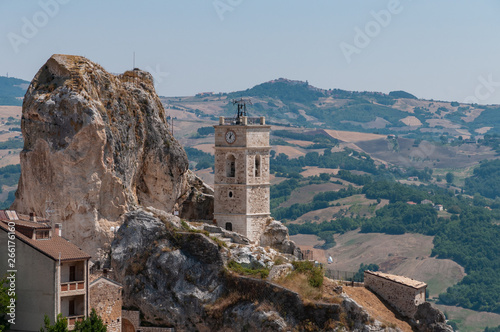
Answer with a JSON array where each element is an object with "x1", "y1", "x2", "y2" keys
[{"x1": 89, "y1": 276, "x2": 123, "y2": 332}]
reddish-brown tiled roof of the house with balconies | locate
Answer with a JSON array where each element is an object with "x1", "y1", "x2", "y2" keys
[{"x1": 0, "y1": 222, "x2": 91, "y2": 261}]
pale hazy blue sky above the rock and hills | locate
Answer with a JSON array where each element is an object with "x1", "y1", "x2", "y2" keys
[{"x1": 0, "y1": 0, "x2": 500, "y2": 104}]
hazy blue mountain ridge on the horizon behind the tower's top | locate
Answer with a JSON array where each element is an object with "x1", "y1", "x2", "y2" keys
[{"x1": 170, "y1": 78, "x2": 500, "y2": 141}]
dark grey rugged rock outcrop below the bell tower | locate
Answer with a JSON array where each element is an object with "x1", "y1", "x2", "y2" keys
[{"x1": 111, "y1": 208, "x2": 390, "y2": 331}]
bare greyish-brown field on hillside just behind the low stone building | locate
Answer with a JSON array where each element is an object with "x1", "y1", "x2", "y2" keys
[{"x1": 291, "y1": 231, "x2": 465, "y2": 297}]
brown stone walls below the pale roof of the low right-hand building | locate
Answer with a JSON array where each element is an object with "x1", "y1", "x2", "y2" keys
[{"x1": 365, "y1": 272, "x2": 425, "y2": 318}]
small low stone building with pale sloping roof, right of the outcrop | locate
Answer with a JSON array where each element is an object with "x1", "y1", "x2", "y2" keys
[{"x1": 364, "y1": 271, "x2": 427, "y2": 318}]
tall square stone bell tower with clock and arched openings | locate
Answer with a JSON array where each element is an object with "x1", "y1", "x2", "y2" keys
[{"x1": 214, "y1": 99, "x2": 271, "y2": 242}]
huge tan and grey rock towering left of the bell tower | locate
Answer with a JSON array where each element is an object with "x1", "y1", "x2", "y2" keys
[{"x1": 12, "y1": 55, "x2": 213, "y2": 258}]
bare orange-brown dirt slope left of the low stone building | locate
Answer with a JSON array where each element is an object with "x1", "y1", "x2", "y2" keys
[{"x1": 343, "y1": 286, "x2": 412, "y2": 332}]
